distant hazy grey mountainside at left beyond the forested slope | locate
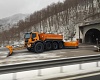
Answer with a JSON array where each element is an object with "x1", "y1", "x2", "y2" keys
[{"x1": 0, "y1": 14, "x2": 29, "y2": 31}]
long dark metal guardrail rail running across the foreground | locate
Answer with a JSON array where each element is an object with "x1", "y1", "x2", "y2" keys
[{"x1": 0, "y1": 55, "x2": 100, "y2": 74}]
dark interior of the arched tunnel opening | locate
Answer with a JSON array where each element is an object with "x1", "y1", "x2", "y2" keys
[{"x1": 85, "y1": 29, "x2": 100, "y2": 44}]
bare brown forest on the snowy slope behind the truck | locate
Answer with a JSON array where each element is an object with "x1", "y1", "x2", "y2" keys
[{"x1": 0, "y1": 0, "x2": 100, "y2": 44}]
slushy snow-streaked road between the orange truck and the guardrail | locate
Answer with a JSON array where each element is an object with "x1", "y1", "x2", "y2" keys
[{"x1": 0, "y1": 44, "x2": 100, "y2": 65}]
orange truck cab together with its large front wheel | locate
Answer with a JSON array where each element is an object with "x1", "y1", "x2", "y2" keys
[{"x1": 24, "y1": 32, "x2": 44, "y2": 53}]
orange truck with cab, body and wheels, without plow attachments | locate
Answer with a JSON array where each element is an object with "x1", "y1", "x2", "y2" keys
[{"x1": 24, "y1": 32, "x2": 63, "y2": 53}]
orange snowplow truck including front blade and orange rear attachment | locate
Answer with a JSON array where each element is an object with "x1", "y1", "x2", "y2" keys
[{"x1": 6, "y1": 32, "x2": 78, "y2": 56}]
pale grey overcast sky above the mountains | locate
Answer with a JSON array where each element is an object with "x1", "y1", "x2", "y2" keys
[{"x1": 0, "y1": 0, "x2": 64, "y2": 19}]
